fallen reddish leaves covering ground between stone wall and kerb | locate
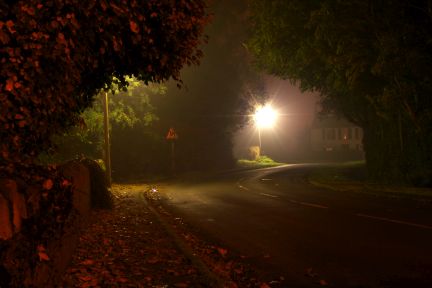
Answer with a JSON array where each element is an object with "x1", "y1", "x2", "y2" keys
[{"x1": 61, "y1": 185, "x2": 211, "y2": 287}]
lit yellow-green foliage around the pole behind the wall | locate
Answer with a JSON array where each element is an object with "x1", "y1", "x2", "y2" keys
[{"x1": 39, "y1": 77, "x2": 166, "y2": 163}]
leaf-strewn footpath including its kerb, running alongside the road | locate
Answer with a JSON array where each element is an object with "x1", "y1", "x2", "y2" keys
[{"x1": 61, "y1": 185, "x2": 264, "y2": 288}]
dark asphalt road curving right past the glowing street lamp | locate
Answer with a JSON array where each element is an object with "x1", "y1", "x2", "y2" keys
[{"x1": 157, "y1": 165, "x2": 432, "y2": 288}]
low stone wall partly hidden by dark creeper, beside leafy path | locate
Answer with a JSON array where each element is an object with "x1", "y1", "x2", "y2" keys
[{"x1": 0, "y1": 161, "x2": 91, "y2": 287}]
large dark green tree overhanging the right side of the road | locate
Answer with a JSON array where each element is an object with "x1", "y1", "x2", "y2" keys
[{"x1": 248, "y1": 0, "x2": 432, "y2": 184}]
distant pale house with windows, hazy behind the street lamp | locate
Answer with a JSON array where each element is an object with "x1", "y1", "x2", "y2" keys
[{"x1": 310, "y1": 115, "x2": 363, "y2": 159}]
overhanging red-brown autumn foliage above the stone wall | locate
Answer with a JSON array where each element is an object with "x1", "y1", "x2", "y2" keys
[{"x1": 0, "y1": 0, "x2": 208, "y2": 171}]
